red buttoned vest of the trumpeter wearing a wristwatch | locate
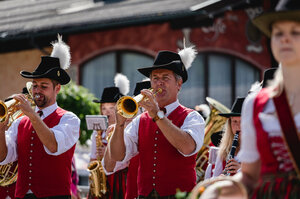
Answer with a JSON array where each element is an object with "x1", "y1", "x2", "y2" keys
[{"x1": 138, "y1": 106, "x2": 196, "y2": 196}]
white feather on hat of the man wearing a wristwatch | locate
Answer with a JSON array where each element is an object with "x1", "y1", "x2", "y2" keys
[{"x1": 178, "y1": 39, "x2": 197, "y2": 70}]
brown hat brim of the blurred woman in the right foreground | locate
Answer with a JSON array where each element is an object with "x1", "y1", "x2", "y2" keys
[{"x1": 252, "y1": 10, "x2": 300, "y2": 37}]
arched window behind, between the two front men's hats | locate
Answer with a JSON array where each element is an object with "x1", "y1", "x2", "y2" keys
[{"x1": 81, "y1": 51, "x2": 153, "y2": 98}]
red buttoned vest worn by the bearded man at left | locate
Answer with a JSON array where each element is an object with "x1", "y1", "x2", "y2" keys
[{"x1": 16, "y1": 108, "x2": 75, "y2": 198}]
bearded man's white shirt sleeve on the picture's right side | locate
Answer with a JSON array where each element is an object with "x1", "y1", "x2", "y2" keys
[{"x1": 44, "y1": 112, "x2": 80, "y2": 156}]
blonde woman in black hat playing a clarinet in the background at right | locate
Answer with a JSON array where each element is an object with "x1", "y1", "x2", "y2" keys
[{"x1": 213, "y1": 98, "x2": 245, "y2": 177}]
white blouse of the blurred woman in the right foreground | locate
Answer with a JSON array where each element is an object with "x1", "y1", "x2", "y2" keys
[{"x1": 238, "y1": 93, "x2": 300, "y2": 163}]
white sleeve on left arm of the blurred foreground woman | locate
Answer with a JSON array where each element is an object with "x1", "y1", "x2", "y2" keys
[{"x1": 238, "y1": 93, "x2": 259, "y2": 163}]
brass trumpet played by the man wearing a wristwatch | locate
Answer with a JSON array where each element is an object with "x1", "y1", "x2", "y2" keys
[{"x1": 117, "y1": 88, "x2": 162, "y2": 118}]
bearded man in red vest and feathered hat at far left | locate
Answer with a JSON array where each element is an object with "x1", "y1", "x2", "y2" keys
[{"x1": 0, "y1": 37, "x2": 80, "y2": 199}]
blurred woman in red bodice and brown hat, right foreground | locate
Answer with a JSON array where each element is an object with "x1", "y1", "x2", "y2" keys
[{"x1": 236, "y1": 0, "x2": 300, "y2": 199}]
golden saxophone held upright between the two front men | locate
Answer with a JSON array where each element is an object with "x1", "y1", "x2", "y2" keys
[{"x1": 88, "y1": 130, "x2": 107, "y2": 198}]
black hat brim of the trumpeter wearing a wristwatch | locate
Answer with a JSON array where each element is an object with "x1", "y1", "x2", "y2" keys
[{"x1": 137, "y1": 61, "x2": 188, "y2": 82}]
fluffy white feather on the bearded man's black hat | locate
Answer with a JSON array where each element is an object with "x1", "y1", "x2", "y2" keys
[{"x1": 50, "y1": 34, "x2": 71, "y2": 70}]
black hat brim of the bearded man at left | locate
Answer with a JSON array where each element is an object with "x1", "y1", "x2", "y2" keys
[{"x1": 20, "y1": 68, "x2": 71, "y2": 85}]
